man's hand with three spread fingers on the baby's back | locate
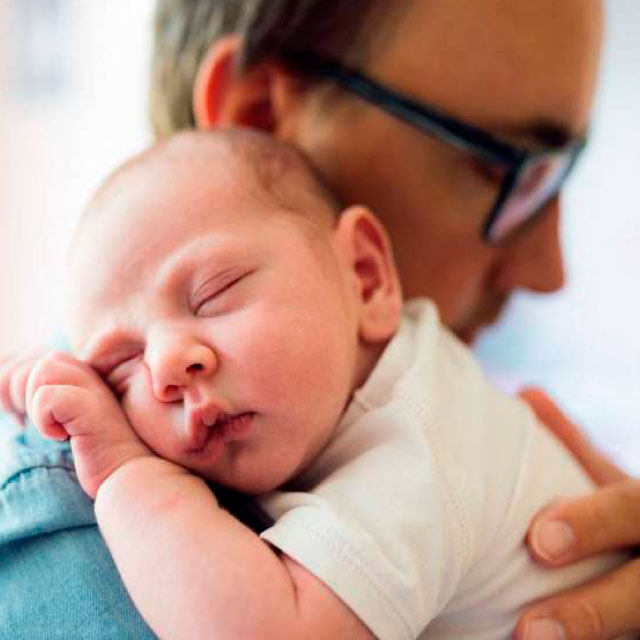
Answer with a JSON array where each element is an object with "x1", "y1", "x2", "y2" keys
[{"x1": 515, "y1": 389, "x2": 640, "y2": 640}]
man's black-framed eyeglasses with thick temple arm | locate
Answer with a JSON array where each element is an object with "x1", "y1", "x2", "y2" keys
[{"x1": 286, "y1": 52, "x2": 586, "y2": 244}]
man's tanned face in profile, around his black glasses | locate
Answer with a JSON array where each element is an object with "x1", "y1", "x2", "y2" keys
[{"x1": 291, "y1": 0, "x2": 601, "y2": 342}]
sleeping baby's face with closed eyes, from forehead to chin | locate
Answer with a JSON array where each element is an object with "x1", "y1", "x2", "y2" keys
[{"x1": 69, "y1": 156, "x2": 359, "y2": 493}]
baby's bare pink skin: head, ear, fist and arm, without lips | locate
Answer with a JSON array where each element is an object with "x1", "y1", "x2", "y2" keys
[{"x1": 26, "y1": 134, "x2": 401, "y2": 639}]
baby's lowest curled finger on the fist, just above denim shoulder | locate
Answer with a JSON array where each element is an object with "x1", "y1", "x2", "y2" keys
[{"x1": 29, "y1": 385, "x2": 83, "y2": 440}]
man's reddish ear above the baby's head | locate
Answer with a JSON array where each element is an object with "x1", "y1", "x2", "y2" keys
[{"x1": 193, "y1": 35, "x2": 304, "y2": 138}]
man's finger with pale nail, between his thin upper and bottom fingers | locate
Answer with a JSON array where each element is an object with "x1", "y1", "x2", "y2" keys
[{"x1": 527, "y1": 480, "x2": 640, "y2": 567}]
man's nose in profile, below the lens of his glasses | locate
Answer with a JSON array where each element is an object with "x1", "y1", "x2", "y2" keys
[{"x1": 494, "y1": 196, "x2": 565, "y2": 293}]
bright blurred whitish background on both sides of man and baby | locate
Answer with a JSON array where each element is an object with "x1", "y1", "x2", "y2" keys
[{"x1": 0, "y1": 0, "x2": 640, "y2": 473}]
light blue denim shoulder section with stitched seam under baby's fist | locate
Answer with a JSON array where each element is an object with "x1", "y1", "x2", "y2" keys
[{"x1": 0, "y1": 414, "x2": 95, "y2": 546}]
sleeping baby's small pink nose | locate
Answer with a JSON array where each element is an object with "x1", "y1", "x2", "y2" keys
[{"x1": 145, "y1": 331, "x2": 218, "y2": 402}]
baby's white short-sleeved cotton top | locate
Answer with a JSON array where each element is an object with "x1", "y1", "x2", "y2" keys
[{"x1": 261, "y1": 300, "x2": 622, "y2": 640}]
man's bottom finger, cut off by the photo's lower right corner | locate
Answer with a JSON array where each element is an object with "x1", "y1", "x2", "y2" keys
[{"x1": 514, "y1": 559, "x2": 640, "y2": 640}]
